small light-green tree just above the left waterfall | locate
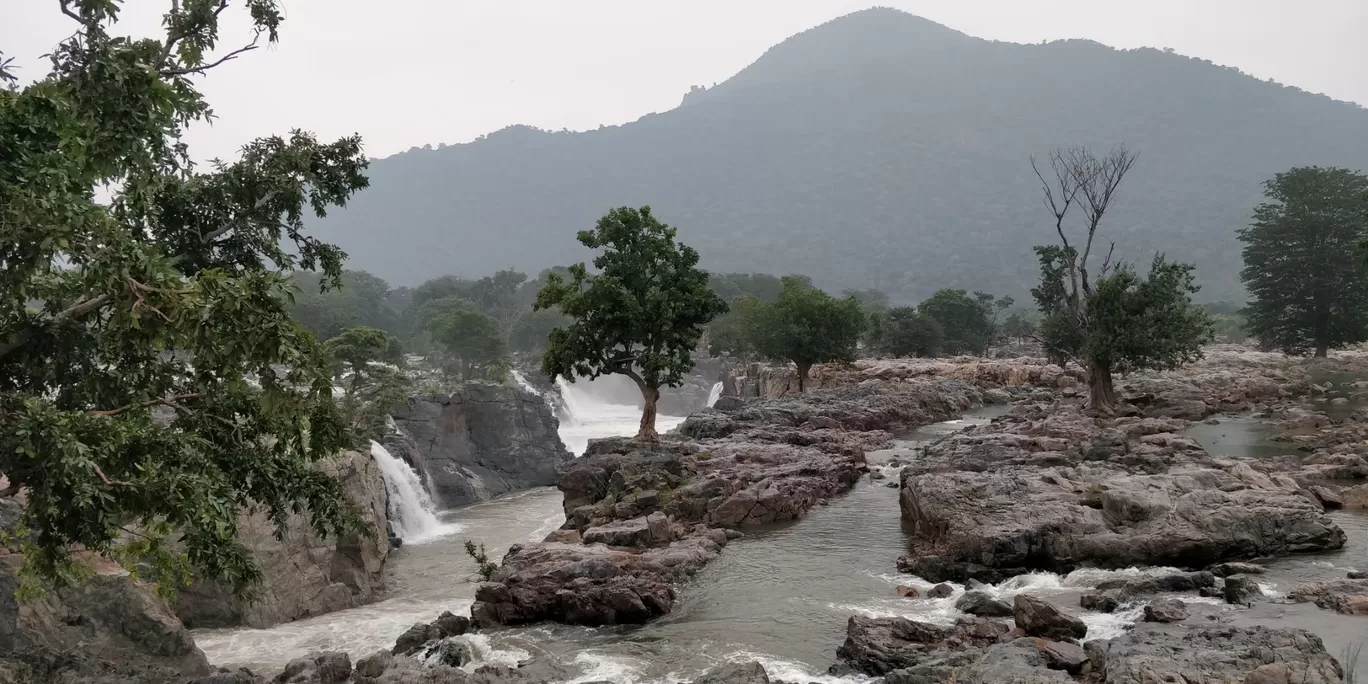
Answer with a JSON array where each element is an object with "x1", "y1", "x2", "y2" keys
[{"x1": 323, "y1": 327, "x2": 410, "y2": 446}]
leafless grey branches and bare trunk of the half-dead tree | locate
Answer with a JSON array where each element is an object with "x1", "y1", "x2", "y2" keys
[{"x1": 1030, "y1": 145, "x2": 1137, "y2": 415}]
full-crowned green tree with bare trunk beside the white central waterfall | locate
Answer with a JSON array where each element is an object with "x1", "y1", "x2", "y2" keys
[{"x1": 535, "y1": 207, "x2": 726, "y2": 442}]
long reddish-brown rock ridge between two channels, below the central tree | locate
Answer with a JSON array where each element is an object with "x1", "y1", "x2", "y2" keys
[{"x1": 472, "y1": 380, "x2": 982, "y2": 625}]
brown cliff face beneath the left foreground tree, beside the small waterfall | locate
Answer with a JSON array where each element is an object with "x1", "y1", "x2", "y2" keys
[{"x1": 175, "y1": 451, "x2": 390, "y2": 628}]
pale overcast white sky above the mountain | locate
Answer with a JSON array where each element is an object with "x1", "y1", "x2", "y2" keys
[{"x1": 0, "y1": 0, "x2": 1368, "y2": 159}]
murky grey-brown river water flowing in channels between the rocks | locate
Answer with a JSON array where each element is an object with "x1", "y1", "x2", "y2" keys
[{"x1": 194, "y1": 387, "x2": 1368, "y2": 684}]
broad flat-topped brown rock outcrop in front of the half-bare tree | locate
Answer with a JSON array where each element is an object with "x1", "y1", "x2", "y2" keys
[{"x1": 900, "y1": 405, "x2": 1345, "y2": 581}]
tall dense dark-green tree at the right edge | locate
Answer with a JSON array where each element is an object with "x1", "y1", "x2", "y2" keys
[{"x1": 1239, "y1": 167, "x2": 1368, "y2": 357}]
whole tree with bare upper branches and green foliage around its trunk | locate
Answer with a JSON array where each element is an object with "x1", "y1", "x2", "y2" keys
[{"x1": 1031, "y1": 146, "x2": 1213, "y2": 416}]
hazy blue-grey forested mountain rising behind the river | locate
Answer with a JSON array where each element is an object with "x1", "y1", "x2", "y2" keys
[{"x1": 314, "y1": 10, "x2": 1368, "y2": 300}]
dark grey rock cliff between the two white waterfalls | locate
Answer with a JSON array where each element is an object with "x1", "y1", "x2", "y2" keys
[{"x1": 384, "y1": 383, "x2": 572, "y2": 508}]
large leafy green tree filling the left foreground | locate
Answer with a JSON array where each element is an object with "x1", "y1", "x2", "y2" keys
[{"x1": 0, "y1": 0, "x2": 367, "y2": 594}]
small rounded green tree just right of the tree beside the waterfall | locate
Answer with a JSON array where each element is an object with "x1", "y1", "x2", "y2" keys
[{"x1": 744, "y1": 278, "x2": 865, "y2": 391}]
